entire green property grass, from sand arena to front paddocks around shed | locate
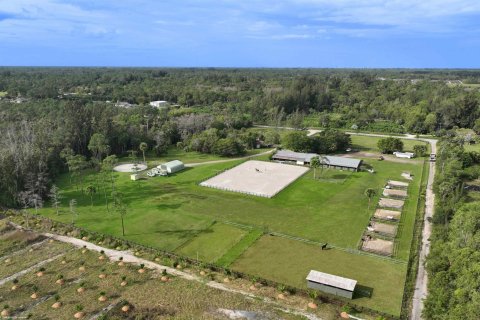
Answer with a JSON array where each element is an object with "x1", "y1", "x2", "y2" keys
[{"x1": 40, "y1": 137, "x2": 423, "y2": 314}]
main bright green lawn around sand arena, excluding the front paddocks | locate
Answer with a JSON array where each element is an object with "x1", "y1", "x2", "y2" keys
[{"x1": 41, "y1": 160, "x2": 422, "y2": 255}]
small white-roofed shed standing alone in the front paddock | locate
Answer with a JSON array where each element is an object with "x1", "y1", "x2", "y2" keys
[{"x1": 307, "y1": 270, "x2": 357, "y2": 299}]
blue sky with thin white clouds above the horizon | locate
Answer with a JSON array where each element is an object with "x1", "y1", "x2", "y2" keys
[{"x1": 0, "y1": 0, "x2": 480, "y2": 68}]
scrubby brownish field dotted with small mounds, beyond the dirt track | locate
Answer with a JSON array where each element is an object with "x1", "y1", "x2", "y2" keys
[{"x1": 0, "y1": 229, "x2": 322, "y2": 320}]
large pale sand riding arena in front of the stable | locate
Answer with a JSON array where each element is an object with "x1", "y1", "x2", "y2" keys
[{"x1": 200, "y1": 160, "x2": 309, "y2": 198}]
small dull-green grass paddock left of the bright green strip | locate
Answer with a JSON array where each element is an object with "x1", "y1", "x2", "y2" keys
[{"x1": 177, "y1": 223, "x2": 247, "y2": 262}]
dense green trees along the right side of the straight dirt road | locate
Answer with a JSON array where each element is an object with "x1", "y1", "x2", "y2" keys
[{"x1": 424, "y1": 134, "x2": 480, "y2": 320}]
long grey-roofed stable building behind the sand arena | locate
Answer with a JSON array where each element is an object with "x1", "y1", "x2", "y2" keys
[{"x1": 272, "y1": 150, "x2": 362, "y2": 171}]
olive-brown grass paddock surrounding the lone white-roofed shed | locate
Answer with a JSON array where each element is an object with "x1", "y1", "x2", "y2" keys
[{"x1": 231, "y1": 235, "x2": 406, "y2": 316}]
